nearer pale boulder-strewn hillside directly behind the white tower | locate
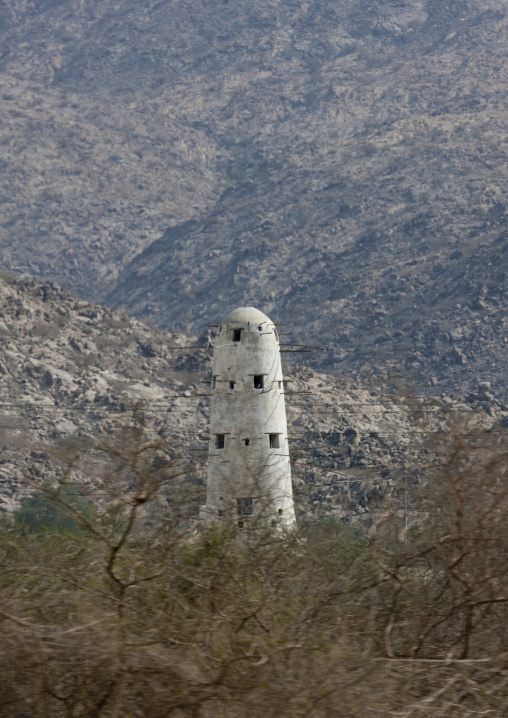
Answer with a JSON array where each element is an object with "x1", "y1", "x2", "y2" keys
[{"x1": 0, "y1": 277, "x2": 508, "y2": 521}]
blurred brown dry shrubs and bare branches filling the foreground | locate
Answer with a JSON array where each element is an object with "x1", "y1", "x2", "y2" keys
[{"x1": 0, "y1": 414, "x2": 508, "y2": 718}]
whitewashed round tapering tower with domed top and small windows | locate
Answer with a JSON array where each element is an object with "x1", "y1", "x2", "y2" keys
[{"x1": 203, "y1": 307, "x2": 296, "y2": 528}]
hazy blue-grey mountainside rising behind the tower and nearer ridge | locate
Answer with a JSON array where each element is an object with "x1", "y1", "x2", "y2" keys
[{"x1": 0, "y1": 0, "x2": 508, "y2": 393}]
